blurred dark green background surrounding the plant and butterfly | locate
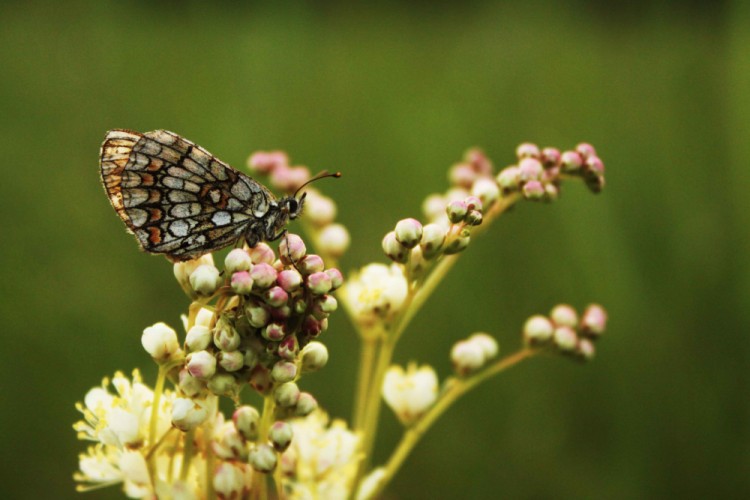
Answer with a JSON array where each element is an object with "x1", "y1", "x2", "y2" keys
[{"x1": 0, "y1": 1, "x2": 750, "y2": 498}]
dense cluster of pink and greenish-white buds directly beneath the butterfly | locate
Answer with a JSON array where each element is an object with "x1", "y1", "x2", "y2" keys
[{"x1": 170, "y1": 234, "x2": 343, "y2": 396}]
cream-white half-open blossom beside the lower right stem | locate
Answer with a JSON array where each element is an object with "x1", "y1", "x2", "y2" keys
[{"x1": 383, "y1": 363, "x2": 438, "y2": 425}]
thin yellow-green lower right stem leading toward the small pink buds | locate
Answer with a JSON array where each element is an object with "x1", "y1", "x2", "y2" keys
[{"x1": 373, "y1": 349, "x2": 537, "y2": 497}]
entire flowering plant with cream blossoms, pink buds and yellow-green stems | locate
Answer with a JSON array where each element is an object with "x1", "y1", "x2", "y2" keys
[{"x1": 74, "y1": 138, "x2": 607, "y2": 499}]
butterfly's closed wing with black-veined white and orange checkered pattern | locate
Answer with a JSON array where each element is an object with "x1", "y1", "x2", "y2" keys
[{"x1": 100, "y1": 130, "x2": 275, "y2": 261}]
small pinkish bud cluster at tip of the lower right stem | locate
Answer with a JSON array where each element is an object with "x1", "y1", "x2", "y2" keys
[{"x1": 523, "y1": 304, "x2": 607, "y2": 361}]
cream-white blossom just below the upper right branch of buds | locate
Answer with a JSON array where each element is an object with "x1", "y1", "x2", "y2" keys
[{"x1": 345, "y1": 264, "x2": 408, "y2": 324}]
